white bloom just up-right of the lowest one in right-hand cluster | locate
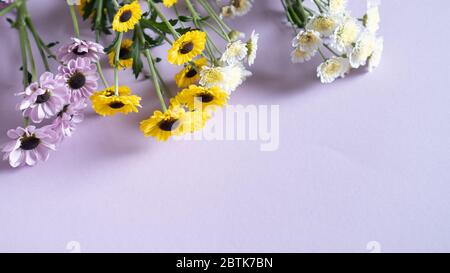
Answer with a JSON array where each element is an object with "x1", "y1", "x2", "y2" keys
[{"x1": 349, "y1": 31, "x2": 376, "y2": 68}]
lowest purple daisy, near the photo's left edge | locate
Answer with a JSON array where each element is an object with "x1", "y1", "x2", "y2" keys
[{"x1": 2, "y1": 126, "x2": 57, "y2": 168}]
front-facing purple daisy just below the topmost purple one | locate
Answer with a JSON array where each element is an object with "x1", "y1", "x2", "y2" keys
[{"x1": 57, "y1": 58, "x2": 99, "y2": 102}]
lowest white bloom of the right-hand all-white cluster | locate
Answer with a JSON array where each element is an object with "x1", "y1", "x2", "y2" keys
[{"x1": 317, "y1": 57, "x2": 350, "y2": 83}]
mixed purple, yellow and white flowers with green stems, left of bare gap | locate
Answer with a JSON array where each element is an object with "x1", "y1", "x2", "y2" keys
[{"x1": 0, "y1": 0, "x2": 258, "y2": 167}]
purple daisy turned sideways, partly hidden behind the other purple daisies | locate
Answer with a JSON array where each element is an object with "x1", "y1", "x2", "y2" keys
[{"x1": 50, "y1": 100, "x2": 87, "y2": 142}]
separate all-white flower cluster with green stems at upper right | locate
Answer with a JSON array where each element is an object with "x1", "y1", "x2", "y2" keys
[{"x1": 282, "y1": 0, "x2": 383, "y2": 83}]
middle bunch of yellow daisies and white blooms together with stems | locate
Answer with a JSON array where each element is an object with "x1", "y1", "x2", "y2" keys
[{"x1": 141, "y1": 0, "x2": 258, "y2": 141}]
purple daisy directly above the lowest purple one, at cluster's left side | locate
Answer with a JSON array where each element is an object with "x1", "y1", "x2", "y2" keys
[{"x1": 17, "y1": 72, "x2": 70, "y2": 123}]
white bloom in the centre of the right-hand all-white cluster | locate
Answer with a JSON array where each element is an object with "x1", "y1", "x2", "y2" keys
[{"x1": 333, "y1": 17, "x2": 361, "y2": 52}]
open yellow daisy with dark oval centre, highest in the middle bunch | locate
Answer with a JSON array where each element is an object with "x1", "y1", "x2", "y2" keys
[{"x1": 167, "y1": 30, "x2": 206, "y2": 65}]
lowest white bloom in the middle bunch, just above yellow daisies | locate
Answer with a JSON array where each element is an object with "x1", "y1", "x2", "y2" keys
[{"x1": 200, "y1": 63, "x2": 252, "y2": 92}]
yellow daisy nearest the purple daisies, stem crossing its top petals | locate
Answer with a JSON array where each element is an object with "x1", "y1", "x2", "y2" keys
[{"x1": 91, "y1": 86, "x2": 141, "y2": 116}]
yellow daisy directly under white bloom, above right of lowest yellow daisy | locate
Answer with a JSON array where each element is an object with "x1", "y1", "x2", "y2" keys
[{"x1": 176, "y1": 85, "x2": 229, "y2": 110}]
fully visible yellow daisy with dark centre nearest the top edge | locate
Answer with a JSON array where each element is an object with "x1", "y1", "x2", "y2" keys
[{"x1": 112, "y1": 1, "x2": 142, "y2": 32}]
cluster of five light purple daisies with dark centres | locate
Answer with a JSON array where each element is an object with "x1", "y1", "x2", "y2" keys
[{"x1": 2, "y1": 38, "x2": 103, "y2": 167}]
